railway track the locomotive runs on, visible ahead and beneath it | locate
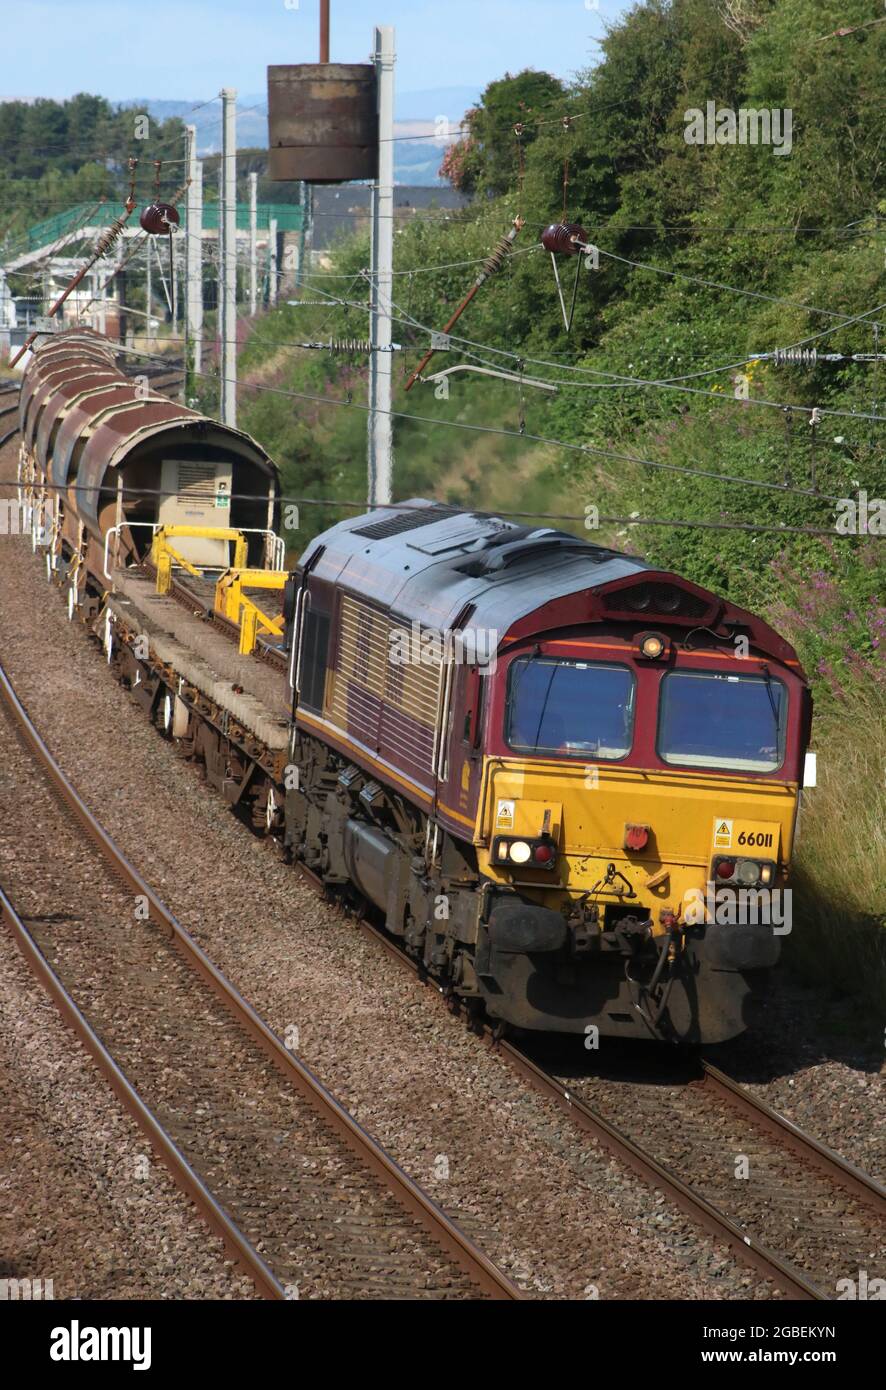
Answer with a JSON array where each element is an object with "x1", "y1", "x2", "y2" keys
[{"x1": 298, "y1": 865, "x2": 886, "y2": 1301}]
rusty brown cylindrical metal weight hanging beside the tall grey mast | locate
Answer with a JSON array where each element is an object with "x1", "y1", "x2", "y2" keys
[{"x1": 267, "y1": 63, "x2": 378, "y2": 183}]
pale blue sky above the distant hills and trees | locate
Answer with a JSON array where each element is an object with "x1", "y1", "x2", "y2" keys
[{"x1": 0, "y1": 0, "x2": 626, "y2": 101}]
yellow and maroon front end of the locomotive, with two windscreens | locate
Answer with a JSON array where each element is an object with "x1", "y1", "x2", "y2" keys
[{"x1": 474, "y1": 589, "x2": 810, "y2": 1043}]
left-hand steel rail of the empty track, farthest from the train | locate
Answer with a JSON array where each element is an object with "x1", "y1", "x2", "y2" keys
[{"x1": 0, "y1": 888, "x2": 287, "y2": 1298}]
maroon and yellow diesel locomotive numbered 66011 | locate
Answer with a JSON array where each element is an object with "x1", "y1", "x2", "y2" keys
[{"x1": 285, "y1": 499, "x2": 811, "y2": 1043}]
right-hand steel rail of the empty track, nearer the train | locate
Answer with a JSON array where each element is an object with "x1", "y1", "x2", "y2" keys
[{"x1": 0, "y1": 666, "x2": 517, "y2": 1300}]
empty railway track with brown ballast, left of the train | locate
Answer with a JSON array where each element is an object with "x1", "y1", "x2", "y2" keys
[{"x1": 0, "y1": 667, "x2": 524, "y2": 1298}]
